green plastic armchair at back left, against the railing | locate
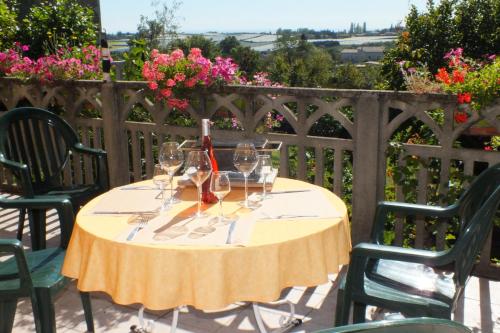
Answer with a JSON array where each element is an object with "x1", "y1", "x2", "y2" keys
[{"x1": 0, "y1": 107, "x2": 109, "y2": 250}]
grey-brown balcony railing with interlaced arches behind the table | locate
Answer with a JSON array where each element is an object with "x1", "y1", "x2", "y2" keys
[{"x1": 0, "y1": 78, "x2": 500, "y2": 279}]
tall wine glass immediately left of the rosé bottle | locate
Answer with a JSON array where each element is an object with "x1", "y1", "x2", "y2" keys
[{"x1": 186, "y1": 150, "x2": 212, "y2": 217}]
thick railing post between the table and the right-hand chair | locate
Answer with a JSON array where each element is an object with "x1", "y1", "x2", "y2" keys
[{"x1": 352, "y1": 92, "x2": 381, "y2": 244}]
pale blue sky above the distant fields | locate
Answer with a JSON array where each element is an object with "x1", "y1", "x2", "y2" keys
[{"x1": 100, "y1": 0, "x2": 434, "y2": 33}]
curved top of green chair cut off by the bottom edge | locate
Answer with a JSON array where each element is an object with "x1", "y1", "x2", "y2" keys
[{"x1": 314, "y1": 318, "x2": 472, "y2": 333}]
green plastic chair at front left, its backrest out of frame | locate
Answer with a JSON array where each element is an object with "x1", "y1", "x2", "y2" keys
[{"x1": 0, "y1": 196, "x2": 94, "y2": 333}]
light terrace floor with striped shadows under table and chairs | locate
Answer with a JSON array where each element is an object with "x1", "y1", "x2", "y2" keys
[{"x1": 0, "y1": 204, "x2": 500, "y2": 333}]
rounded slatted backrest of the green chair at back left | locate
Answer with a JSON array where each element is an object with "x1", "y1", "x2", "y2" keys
[{"x1": 0, "y1": 107, "x2": 78, "y2": 196}]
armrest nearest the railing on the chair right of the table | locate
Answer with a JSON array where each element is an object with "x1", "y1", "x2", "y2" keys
[{"x1": 372, "y1": 201, "x2": 458, "y2": 244}]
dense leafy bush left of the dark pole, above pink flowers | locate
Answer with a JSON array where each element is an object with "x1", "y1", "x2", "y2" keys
[{"x1": 21, "y1": 0, "x2": 97, "y2": 58}]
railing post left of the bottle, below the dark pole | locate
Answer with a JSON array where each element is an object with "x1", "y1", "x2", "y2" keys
[{"x1": 101, "y1": 82, "x2": 130, "y2": 188}]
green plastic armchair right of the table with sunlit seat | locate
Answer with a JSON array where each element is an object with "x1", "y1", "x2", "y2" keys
[{"x1": 335, "y1": 164, "x2": 500, "y2": 326}]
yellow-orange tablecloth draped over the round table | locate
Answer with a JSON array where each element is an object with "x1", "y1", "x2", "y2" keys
[{"x1": 62, "y1": 178, "x2": 351, "y2": 310}]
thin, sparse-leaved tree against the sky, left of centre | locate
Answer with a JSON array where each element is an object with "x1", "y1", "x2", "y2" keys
[{"x1": 137, "y1": 0, "x2": 182, "y2": 49}]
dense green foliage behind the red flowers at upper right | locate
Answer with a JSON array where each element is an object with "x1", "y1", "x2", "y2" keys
[{"x1": 382, "y1": 0, "x2": 500, "y2": 89}]
